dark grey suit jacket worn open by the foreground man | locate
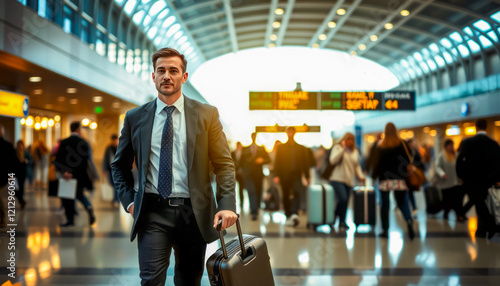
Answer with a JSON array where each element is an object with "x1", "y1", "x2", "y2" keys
[{"x1": 111, "y1": 96, "x2": 236, "y2": 243}]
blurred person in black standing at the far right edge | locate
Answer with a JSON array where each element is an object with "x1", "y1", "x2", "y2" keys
[{"x1": 456, "y1": 119, "x2": 500, "y2": 238}]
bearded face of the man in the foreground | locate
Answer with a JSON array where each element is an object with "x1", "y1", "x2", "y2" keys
[{"x1": 153, "y1": 57, "x2": 188, "y2": 96}]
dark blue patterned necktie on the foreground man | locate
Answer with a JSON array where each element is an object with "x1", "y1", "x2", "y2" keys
[{"x1": 158, "y1": 106, "x2": 175, "y2": 199}]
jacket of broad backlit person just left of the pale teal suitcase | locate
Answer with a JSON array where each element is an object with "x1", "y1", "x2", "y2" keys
[{"x1": 274, "y1": 141, "x2": 310, "y2": 180}]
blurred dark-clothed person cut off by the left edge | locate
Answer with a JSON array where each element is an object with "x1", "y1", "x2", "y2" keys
[{"x1": 0, "y1": 124, "x2": 20, "y2": 228}]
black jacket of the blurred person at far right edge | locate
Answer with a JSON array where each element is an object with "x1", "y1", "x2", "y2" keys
[{"x1": 456, "y1": 134, "x2": 500, "y2": 188}]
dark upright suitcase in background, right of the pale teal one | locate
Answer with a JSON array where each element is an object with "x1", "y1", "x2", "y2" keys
[{"x1": 354, "y1": 186, "x2": 376, "y2": 228}]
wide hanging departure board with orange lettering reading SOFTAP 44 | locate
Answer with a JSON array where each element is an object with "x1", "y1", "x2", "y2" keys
[{"x1": 250, "y1": 91, "x2": 415, "y2": 110}]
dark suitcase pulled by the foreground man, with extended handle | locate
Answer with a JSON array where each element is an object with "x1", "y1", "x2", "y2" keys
[{"x1": 207, "y1": 219, "x2": 274, "y2": 286}]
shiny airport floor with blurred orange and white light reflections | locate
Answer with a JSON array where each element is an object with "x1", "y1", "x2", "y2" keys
[{"x1": 0, "y1": 184, "x2": 500, "y2": 286}]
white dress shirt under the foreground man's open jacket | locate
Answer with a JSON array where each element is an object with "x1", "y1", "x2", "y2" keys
[{"x1": 145, "y1": 95, "x2": 189, "y2": 198}]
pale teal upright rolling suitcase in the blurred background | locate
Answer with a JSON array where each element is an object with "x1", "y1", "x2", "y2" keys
[{"x1": 307, "y1": 184, "x2": 335, "y2": 229}]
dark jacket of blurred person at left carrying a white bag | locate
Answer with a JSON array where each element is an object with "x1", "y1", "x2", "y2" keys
[{"x1": 52, "y1": 135, "x2": 93, "y2": 190}]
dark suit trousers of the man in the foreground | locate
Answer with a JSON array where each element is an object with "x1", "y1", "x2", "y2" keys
[{"x1": 137, "y1": 193, "x2": 207, "y2": 286}]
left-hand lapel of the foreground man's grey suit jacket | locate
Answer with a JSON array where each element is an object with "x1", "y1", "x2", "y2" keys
[{"x1": 141, "y1": 99, "x2": 156, "y2": 182}]
